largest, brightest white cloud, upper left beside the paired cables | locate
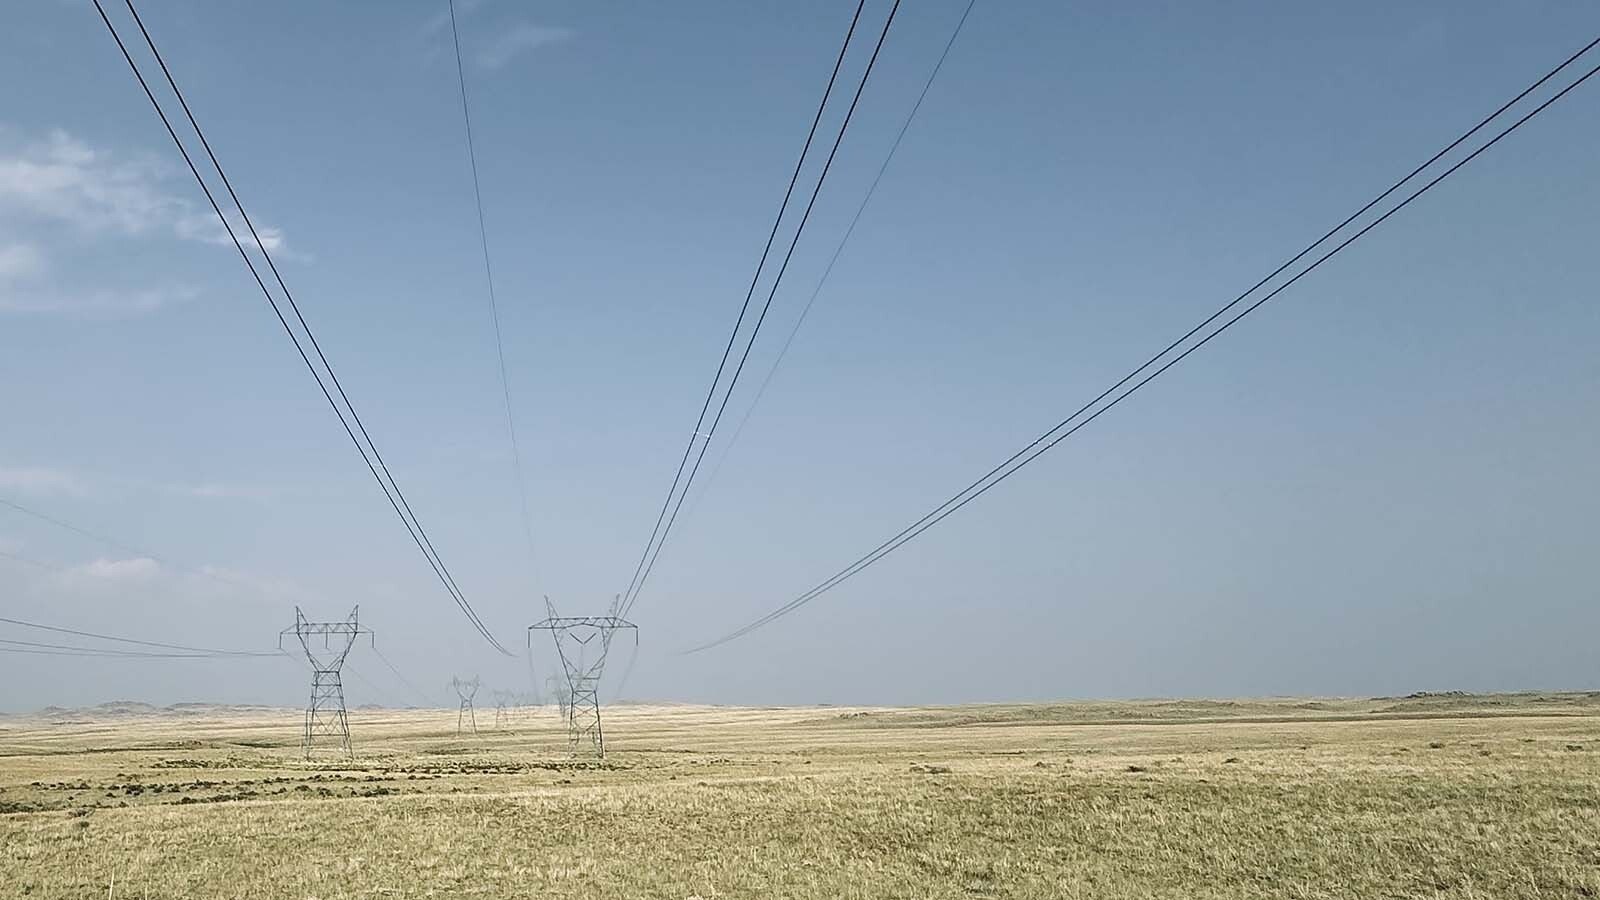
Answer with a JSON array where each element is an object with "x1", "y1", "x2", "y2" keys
[{"x1": 0, "y1": 130, "x2": 283, "y2": 251}]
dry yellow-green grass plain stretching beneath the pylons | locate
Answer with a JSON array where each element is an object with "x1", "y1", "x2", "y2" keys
[{"x1": 0, "y1": 693, "x2": 1600, "y2": 900}]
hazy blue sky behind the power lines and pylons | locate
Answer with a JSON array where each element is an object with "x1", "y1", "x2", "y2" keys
[{"x1": 0, "y1": 0, "x2": 1600, "y2": 708}]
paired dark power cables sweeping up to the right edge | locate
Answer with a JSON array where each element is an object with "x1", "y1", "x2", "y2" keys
[{"x1": 688, "y1": 38, "x2": 1600, "y2": 653}]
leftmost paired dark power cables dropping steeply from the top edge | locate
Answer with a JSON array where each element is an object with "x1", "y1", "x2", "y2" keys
[{"x1": 94, "y1": 0, "x2": 512, "y2": 657}]
